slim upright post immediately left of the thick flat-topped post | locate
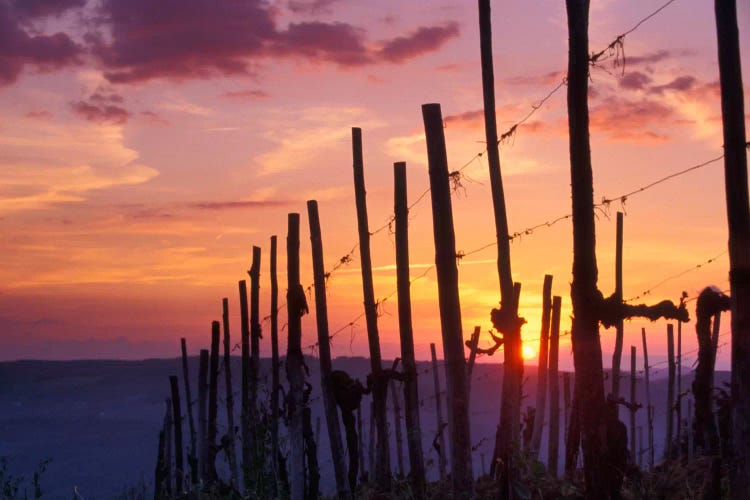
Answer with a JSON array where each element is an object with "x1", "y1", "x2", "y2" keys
[{"x1": 393, "y1": 162, "x2": 425, "y2": 500}]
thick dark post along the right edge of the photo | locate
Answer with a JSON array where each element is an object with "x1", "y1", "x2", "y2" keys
[{"x1": 714, "y1": 0, "x2": 750, "y2": 492}]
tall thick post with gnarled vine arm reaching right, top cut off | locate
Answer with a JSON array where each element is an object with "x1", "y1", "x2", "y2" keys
[{"x1": 566, "y1": 0, "x2": 613, "y2": 492}]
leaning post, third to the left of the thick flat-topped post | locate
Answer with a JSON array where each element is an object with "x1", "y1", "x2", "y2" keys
[{"x1": 307, "y1": 200, "x2": 352, "y2": 500}]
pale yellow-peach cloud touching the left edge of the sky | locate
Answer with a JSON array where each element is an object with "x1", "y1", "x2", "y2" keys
[{"x1": 0, "y1": 116, "x2": 158, "y2": 213}]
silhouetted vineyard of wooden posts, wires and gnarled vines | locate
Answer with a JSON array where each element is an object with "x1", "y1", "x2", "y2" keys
[{"x1": 141, "y1": 0, "x2": 750, "y2": 500}]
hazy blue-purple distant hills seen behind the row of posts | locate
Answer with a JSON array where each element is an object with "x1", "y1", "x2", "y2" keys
[{"x1": 0, "y1": 357, "x2": 729, "y2": 499}]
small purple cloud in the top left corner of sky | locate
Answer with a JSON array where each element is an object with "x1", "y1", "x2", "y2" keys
[{"x1": 0, "y1": 0, "x2": 83, "y2": 86}]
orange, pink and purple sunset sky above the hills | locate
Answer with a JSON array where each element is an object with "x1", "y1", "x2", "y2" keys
[{"x1": 0, "y1": 0, "x2": 750, "y2": 376}]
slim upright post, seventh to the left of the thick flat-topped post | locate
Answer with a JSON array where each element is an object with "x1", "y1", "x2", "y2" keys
[{"x1": 238, "y1": 280, "x2": 253, "y2": 488}]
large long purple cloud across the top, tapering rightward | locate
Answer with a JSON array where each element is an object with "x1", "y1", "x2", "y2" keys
[{"x1": 91, "y1": 0, "x2": 458, "y2": 83}]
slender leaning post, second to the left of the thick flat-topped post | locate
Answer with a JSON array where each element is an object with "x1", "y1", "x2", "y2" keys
[{"x1": 352, "y1": 128, "x2": 391, "y2": 491}]
